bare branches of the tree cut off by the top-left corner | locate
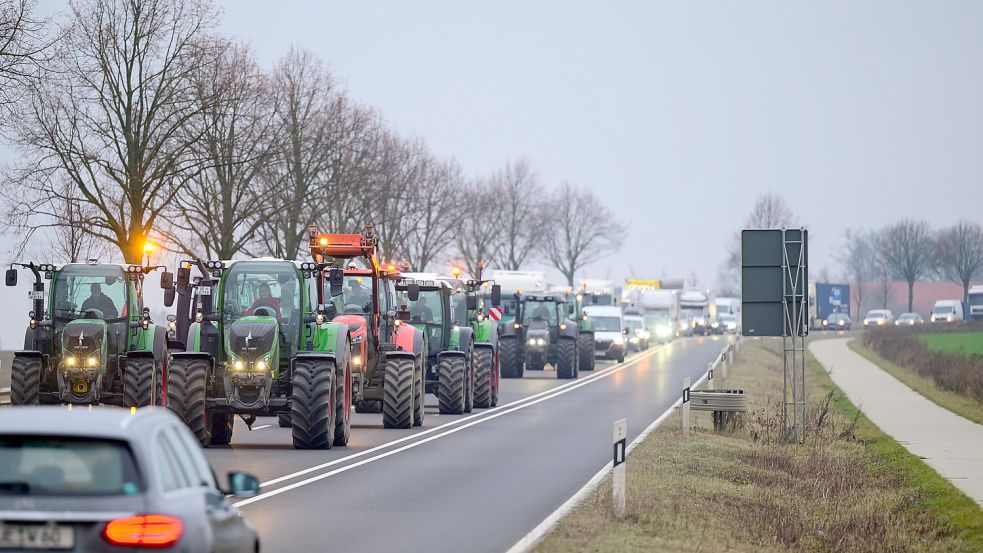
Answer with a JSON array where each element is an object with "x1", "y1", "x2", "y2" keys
[{"x1": 0, "y1": 0, "x2": 52, "y2": 122}]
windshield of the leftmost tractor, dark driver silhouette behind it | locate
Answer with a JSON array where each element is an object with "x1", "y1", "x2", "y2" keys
[{"x1": 52, "y1": 265, "x2": 130, "y2": 325}]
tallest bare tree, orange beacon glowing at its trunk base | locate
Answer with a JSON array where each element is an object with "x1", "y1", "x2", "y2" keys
[{"x1": 7, "y1": 0, "x2": 214, "y2": 263}]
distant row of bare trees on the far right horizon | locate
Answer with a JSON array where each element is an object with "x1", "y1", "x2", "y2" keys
[{"x1": 843, "y1": 219, "x2": 983, "y2": 311}]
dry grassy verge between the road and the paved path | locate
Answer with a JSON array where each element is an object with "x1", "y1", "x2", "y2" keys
[{"x1": 537, "y1": 341, "x2": 983, "y2": 553}]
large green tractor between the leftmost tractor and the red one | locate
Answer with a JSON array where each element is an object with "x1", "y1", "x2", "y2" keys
[{"x1": 162, "y1": 258, "x2": 352, "y2": 449}]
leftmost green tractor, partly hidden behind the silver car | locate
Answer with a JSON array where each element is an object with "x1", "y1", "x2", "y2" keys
[{"x1": 6, "y1": 261, "x2": 167, "y2": 407}]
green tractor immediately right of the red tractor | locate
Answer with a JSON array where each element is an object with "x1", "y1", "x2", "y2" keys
[{"x1": 396, "y1": 273, "x2": 477, "y2": 415}]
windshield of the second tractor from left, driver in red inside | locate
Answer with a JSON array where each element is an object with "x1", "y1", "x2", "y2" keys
[{"x1": 222, "y1": 261, "x2": 303, "y2": 344}]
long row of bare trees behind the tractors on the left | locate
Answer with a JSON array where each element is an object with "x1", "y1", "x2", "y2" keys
[{"x1": 0, "y1": 0, "x2": 624, "y2": 282}]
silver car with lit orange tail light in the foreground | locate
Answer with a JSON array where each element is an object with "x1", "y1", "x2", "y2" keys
[{"x1": 0, "y1": 406, "x2": 259, "y2": 552}]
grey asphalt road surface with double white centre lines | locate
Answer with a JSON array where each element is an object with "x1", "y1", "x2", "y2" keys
[{"x1": 206, "y1": 337, "x2": 726, "y2": 553}]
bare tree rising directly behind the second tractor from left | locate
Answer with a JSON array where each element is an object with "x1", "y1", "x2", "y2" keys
[{"x1": 168, "y1": 38, "x2": 273, "y2": 259}]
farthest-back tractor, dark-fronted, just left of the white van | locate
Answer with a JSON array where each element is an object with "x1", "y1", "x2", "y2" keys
[{"x1": 499, "y1": 292, "x2": 594, "y2": 380}]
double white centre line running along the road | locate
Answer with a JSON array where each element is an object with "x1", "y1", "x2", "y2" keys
[{"x1": 234, "y1": 348, "x2": 662, "y2": 507}]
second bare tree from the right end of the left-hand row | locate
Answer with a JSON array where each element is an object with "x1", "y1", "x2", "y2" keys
[{"x1": 492, "y1": 159, "x2": 545, "y2": 271}]
